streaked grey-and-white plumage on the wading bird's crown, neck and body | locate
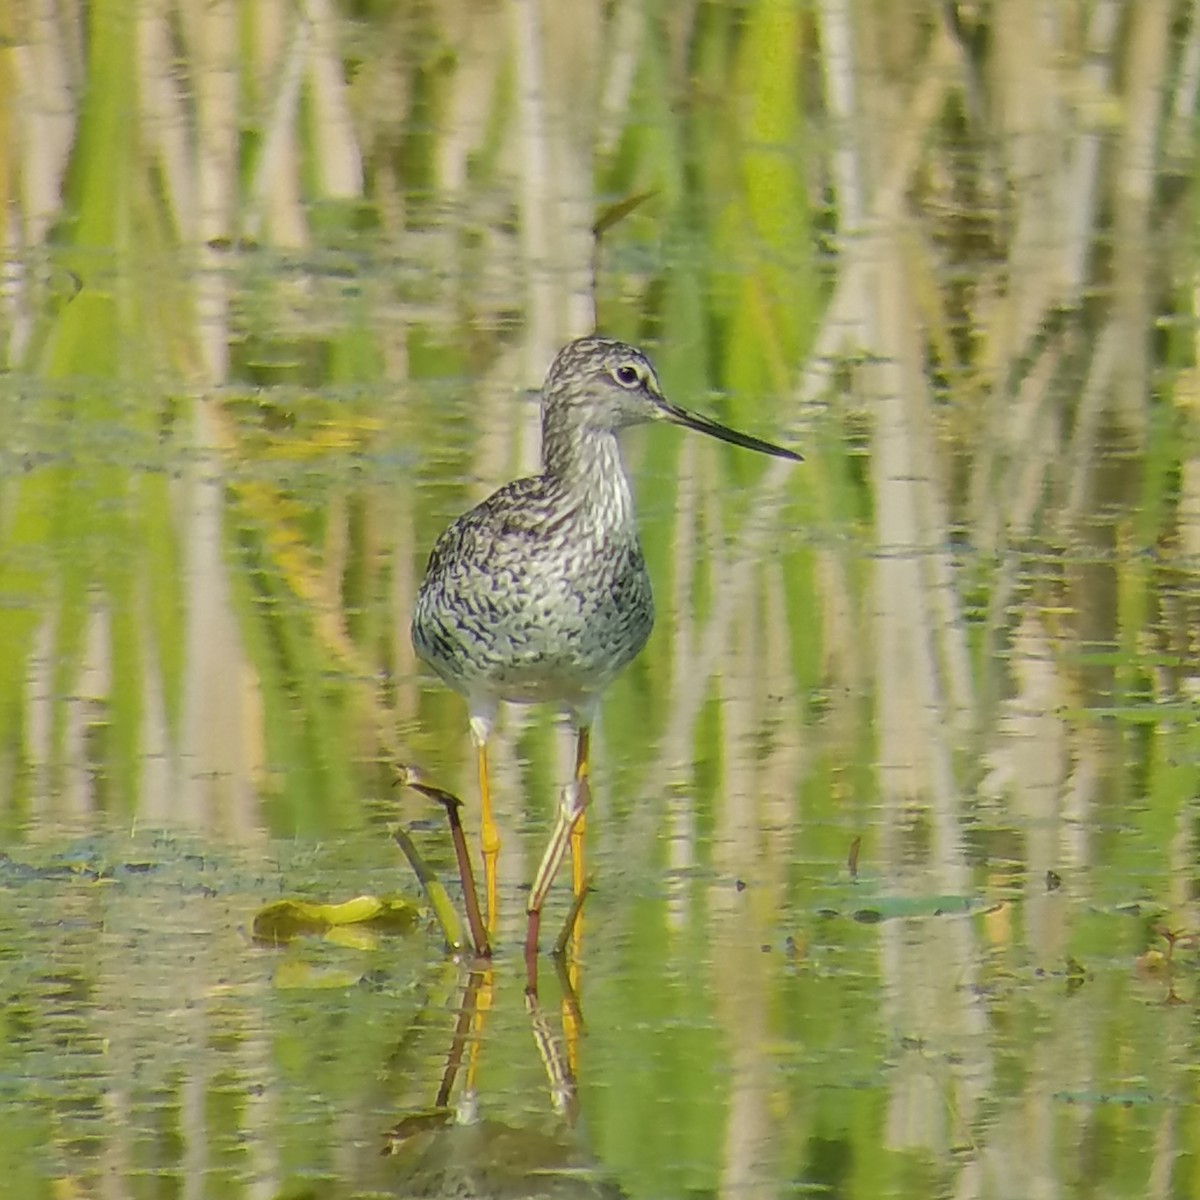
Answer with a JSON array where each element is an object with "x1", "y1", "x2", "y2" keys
[{"x1": 413, "y1": 338, "x2": 654, "y2": 736}]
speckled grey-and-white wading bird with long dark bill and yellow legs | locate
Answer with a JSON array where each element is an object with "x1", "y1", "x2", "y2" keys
[{"x1": 412, "y1": 337, "x2": 800, "y2": 953}]
